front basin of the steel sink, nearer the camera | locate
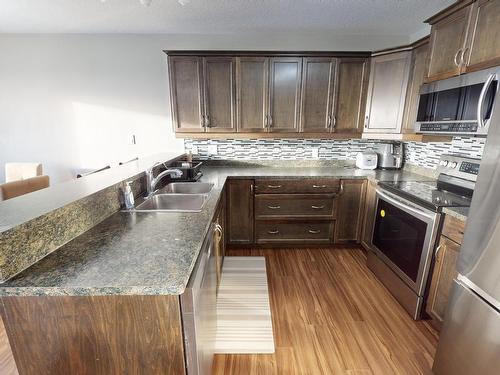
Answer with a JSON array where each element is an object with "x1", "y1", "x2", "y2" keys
[{"x1": 134, "y1": 194, "x2": 208, "y2": 212}]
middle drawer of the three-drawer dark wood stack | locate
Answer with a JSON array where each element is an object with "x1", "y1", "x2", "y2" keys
[{"x1": 255, "y1": 194, "x2": 335, "y2": 219}]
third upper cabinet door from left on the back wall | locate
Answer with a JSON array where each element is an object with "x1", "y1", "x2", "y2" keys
[{"x1": 236, "y1": 57, "x2": 269, "y2": 133}]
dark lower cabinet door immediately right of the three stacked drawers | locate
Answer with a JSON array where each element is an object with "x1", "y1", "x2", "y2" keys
[{"x1": 335, "y1": 180, "x2": 366, "y2": 243}]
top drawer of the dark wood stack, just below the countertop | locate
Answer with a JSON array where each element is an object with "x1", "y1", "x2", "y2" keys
[{"x1": 255, "y1": 178, "x2": 340, "y2": 194}]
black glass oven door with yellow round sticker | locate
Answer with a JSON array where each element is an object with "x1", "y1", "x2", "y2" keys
[{"x1": 372, "y1": 188, "x2": 440, "y2": 296}]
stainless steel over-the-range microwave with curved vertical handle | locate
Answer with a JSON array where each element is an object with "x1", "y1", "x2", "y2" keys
[{"x1": 415, "y1": 67, "x2": 500, "y2": 136}]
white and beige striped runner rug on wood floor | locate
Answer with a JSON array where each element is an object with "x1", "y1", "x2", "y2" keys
[{"x1": 215, "y1": 257, "x2": 274, "y2": 353}]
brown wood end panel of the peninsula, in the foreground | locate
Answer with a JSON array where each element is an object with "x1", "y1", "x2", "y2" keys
[{"x1": 0, "y1": 295, "x2": 185, "y2": 375}]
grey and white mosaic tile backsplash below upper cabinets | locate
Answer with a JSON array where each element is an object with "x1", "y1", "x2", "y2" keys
[{"x1": 184, "y1": 137, "x2": 485, "y2": 169}]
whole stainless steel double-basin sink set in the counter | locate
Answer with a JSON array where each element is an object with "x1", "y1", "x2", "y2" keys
[{"x1": 133, "y1": 182, "x2": 214, "y2": 212}]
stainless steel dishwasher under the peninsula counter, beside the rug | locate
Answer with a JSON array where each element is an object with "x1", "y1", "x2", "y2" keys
[{"x1": 181, "y1": 225, "x2": 217, "y2": 375}]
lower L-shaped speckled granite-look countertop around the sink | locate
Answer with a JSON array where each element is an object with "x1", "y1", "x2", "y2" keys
[{"x1": 0, "y1": 165, "x2": 429, "y2": 296}]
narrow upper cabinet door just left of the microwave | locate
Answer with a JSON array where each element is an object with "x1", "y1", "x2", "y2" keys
[{"x1": 403, "y1": 43, "x2": 429, "y2": 133}]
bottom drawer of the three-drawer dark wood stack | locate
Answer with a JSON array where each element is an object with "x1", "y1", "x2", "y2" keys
[{"x1": 255, "y1": 221, "x2": 334, "y2": 243}]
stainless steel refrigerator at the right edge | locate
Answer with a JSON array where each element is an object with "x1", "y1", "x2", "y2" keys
[{"x1": 433, "y1": 78, "x2": 500, "y2": 375}]
